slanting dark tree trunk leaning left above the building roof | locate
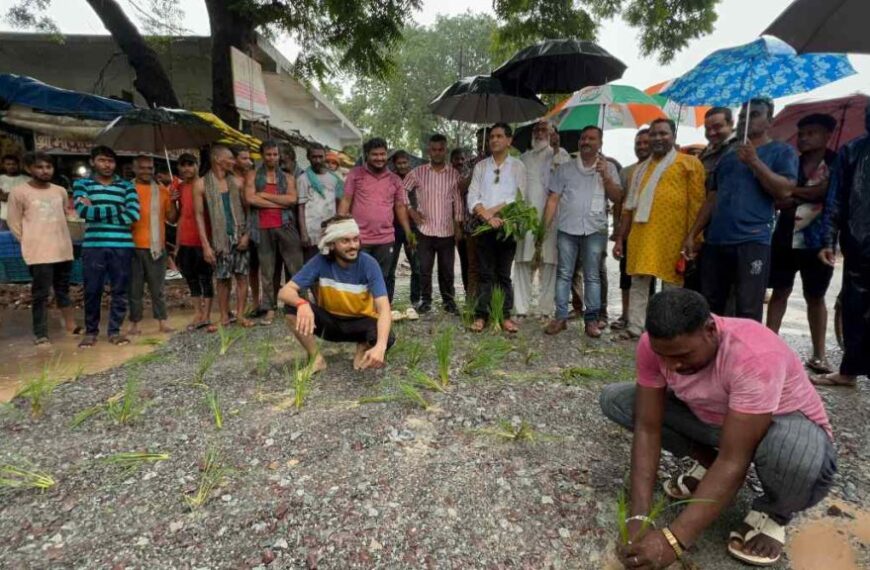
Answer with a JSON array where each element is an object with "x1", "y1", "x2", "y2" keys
[{"x1": 87, "y1": 0, "x2": 181, "y2": 108}]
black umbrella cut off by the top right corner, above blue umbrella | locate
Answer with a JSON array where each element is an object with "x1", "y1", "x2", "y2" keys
[{"x1": 764, "y1": 0, "x2": 870, "y2": 53}]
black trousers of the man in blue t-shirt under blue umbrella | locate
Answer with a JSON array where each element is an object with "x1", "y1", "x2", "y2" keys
[{"x1": 701, "y1": 243, "x2": 770, "y2": 322}]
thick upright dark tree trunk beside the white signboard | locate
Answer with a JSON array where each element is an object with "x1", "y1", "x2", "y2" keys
[{"x1": 205, "y1": 0, "x2": 256, "y2": 129}]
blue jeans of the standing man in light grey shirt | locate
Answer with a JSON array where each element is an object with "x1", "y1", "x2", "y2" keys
[{"x1": 556, "y1": 231, "x2": 607, "y2": 323}]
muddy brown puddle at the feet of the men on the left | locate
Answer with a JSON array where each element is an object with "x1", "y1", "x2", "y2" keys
[{"x1": 0, "y1": 309, "x2": 193, "y2": 402}]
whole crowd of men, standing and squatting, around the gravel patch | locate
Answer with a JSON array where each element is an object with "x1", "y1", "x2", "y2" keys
[{"x1": 0, "y1": 99, "x2": 870, "y2": 568}]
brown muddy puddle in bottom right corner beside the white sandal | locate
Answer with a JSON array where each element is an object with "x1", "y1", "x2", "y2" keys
[{"x1": 786, "y1": 501, "x2": 870, "y2": 570}]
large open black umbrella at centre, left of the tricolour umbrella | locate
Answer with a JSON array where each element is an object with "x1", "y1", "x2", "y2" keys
[{"x1": 492, "y1": 40, "x2": 625, "y2": 93}]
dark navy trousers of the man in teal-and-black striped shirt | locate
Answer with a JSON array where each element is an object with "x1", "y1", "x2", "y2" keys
[{"x1": 82, "y1": 247, "x2": 133, "y2": 336}]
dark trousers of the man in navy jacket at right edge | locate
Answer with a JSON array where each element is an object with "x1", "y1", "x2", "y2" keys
[{"x1": 840, "y1": 254, "x2": 870, "y2": 376}]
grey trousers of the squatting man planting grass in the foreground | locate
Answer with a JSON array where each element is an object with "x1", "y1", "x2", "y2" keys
[{"x1": 600, "y1": 383, "x2": 837, "y2": 525}]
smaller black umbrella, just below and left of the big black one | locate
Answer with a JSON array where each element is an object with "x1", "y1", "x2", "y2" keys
[{"x1": 429, "y1": 75, "x2": 547, "y2": 123}]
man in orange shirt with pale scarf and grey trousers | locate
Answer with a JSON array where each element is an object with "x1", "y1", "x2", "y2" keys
[{"x1": 128, "y1": 156, "x2": 178, "y2": 336}]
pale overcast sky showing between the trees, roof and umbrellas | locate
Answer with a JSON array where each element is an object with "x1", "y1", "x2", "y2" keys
[{"x1": 0, "y1": 0, "x2": 870, "y2": 163}]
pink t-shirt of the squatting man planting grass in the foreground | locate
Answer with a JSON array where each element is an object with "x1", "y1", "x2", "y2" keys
[{"x1": 637, "y1": 316, "x2": 833, "y2": 437}]
